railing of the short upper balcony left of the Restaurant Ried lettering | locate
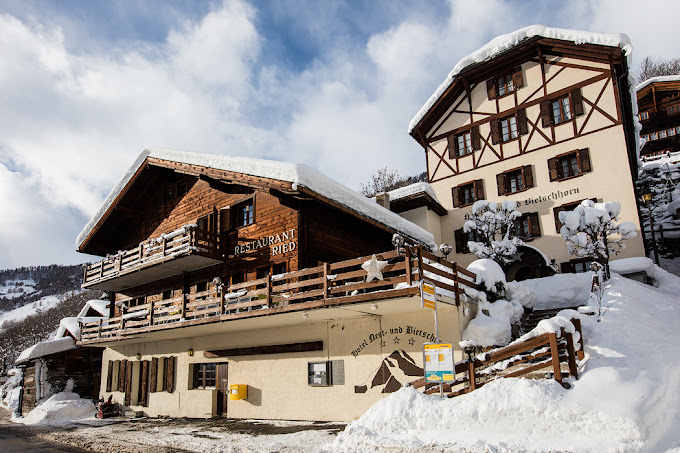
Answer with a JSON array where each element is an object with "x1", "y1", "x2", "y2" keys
[{"x1": 83, "y1": 225, "x2": 223, "y2": 289}]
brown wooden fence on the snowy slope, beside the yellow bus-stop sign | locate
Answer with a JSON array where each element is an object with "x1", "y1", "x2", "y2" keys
[{"x1": 410, "y1": 319, "x2": 583, "y2": 397}]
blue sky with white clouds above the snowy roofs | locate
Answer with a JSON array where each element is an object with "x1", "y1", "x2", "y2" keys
[{"x1": 0, "y1": 0, "x2": 680, "y2": 268}]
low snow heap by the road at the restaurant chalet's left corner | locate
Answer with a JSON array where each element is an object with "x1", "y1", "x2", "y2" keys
[{"x1": 13, "y1": 391, "x2": 96, "y2": 425}]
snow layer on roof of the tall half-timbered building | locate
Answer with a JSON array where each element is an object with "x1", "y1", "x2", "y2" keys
[{"x1": 408, "y1": 25, "x2": 632, "y2": 133}]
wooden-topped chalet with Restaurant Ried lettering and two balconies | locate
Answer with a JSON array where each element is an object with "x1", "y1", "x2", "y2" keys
[{"x1": 77, "y1": 149, "x2": 476, "y2": 421}]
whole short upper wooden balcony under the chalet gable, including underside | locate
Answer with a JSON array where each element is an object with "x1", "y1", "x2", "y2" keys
[{"x1": 82, "y1": 225, "x2": 224, "y2": 291}]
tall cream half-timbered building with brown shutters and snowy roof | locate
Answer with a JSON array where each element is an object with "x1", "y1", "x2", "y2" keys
[{"x1": 409, "y1": 26, "x2": 644, "y2": 279}]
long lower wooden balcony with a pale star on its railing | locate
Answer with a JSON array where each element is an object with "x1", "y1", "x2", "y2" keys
[{"x1": 80, "y1": 247, "x2": 481, "y2": 344}]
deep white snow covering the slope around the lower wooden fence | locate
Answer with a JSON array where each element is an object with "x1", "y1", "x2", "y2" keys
[{"x1": 328, "y1": 268, "x2": 680, "y2": 453}]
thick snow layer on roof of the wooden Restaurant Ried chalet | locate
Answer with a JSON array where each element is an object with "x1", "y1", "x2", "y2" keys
[{"x1": 76, "y1": 148, "x2": 436, "y2": 250}]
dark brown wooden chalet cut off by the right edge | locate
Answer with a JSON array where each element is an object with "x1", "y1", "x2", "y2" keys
[{"x1": 636, "y1": 75, "x2": 680, "y2": 159}]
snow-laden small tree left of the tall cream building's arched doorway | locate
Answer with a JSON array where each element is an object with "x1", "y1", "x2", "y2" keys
[{"x1": 463, "y1": 200, "x2": 524, "y2": 266}]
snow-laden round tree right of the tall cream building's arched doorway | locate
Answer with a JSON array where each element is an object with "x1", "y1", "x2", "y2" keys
[{"x1": 559, "y1": 200, "x2": 637, "y2": 276}]
